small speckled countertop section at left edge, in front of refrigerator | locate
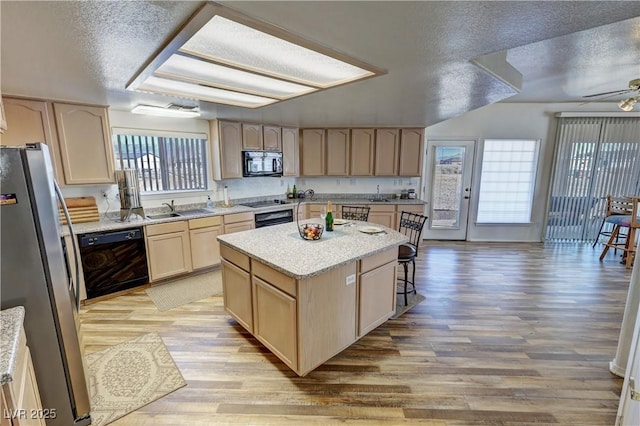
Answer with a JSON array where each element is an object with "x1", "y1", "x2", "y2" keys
[{"x1": 0, "y1": 306, "x2": 24, "y2": 385}]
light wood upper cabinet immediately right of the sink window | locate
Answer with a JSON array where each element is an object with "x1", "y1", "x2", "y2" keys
[{"x1": 209, "y1": 120, "x2": 242, "y2": 180}]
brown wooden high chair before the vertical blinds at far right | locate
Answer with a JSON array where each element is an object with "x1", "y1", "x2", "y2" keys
[{"x1": 600, "y1": 197, "x2": 640, "y2": 268}]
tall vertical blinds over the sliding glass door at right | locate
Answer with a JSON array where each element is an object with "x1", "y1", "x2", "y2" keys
[{"x1": 546, "y1": 117, "x2": 640, "y2": 242}]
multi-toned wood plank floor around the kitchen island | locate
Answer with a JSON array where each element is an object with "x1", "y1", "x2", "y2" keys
[{"x1": 81, "y1": 242, "x2": 631, "y2": 426}]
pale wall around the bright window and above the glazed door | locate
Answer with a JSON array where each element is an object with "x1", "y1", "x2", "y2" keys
[{"x1": 425, "y1": 99, "x2": 619, "y2": 242}]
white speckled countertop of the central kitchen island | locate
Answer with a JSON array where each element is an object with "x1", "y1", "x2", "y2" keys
[{"x1": 218, "y1": 219, "x2": 408, "y2": 279}]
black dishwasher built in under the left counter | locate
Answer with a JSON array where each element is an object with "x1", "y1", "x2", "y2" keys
[{"x1": 78, "y1": 228, "x2": 149, "y2": 299}]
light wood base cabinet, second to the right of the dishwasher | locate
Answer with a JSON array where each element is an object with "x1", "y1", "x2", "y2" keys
[{"x1": 189, "y1": 216, "x2": 222, "y2": 270}]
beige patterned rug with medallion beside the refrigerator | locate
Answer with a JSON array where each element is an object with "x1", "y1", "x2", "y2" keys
[{"x1": 85, "y1": 333, "x2": 187, "y2": 426}]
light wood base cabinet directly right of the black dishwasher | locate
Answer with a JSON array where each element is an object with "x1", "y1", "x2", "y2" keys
[{"x1": 145, "y1": 220, "x2": 192, "y2": 282}]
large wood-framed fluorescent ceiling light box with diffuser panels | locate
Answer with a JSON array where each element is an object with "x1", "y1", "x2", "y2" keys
[{"x1": 127, "y1": 2, "x2": 386, "y2": 108}]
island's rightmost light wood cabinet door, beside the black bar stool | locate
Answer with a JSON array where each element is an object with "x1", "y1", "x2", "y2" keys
[{"x1": 358, "y1": 258, "x2": 398, "y2": 337}]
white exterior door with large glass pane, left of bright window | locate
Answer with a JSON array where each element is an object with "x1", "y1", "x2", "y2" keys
[{"x1": 422, "y1": 140, "x2": 476, "y2": 241}]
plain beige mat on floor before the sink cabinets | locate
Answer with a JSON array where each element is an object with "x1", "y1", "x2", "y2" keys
[{"x1": 146, "y1": 270, "x2": 222, "y2": 311}]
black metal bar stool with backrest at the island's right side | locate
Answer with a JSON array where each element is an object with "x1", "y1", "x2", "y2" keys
[{"x1": 398, "y1": 211, "x2": 427, "y2": 306}]
